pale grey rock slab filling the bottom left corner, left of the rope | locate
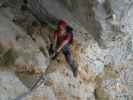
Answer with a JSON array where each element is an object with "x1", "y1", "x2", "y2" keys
[{"x1": 0, "y1": 68, "x2": 28, "y2": 100}]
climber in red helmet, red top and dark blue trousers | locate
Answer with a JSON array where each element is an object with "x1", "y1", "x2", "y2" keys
[{"x1": 48, "y1": 20, "x2": 78, "y2": 77}]
